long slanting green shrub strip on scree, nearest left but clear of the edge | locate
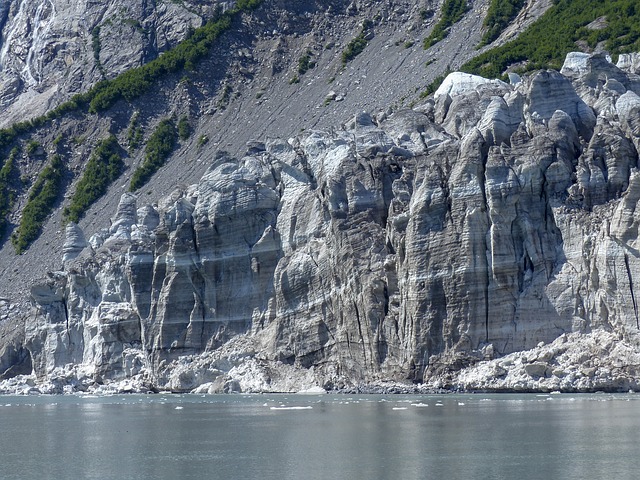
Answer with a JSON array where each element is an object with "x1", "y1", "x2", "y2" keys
[{"x1": 11, "y1": 155, "x2": 64, "y2": 254}]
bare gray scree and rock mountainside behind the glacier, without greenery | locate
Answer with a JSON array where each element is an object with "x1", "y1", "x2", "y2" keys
[{"x1": 0, "y1": 0, "x2": 500, "y2": 308}]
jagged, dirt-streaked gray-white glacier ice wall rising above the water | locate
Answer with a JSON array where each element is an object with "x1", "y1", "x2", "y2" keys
[{"x1": 15, "y1": 52, "x2": 640, "y2": 391}]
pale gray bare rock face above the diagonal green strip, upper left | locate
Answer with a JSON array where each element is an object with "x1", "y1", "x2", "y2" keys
[{"x1": 0, "y1": 0, "x2": 217, "y2": 126}]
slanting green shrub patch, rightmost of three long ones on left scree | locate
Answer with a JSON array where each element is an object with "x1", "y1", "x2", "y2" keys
[{"x1": 129, "y1": 119, "x2": 178, "y2": 192}]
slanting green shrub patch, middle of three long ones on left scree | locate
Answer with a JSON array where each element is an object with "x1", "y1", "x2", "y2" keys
[{"x1": 63, "y1": 135, "x2": 124, "y2": 222}]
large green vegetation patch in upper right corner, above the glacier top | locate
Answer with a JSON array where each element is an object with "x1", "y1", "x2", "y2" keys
[{"x1": 462, "y1": 0, "x2": 640, "y2": 78}]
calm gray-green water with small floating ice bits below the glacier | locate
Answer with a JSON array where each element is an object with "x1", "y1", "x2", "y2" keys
[{"x1": 0, "y1": 394, "x2": 640, "y2": 480}]
